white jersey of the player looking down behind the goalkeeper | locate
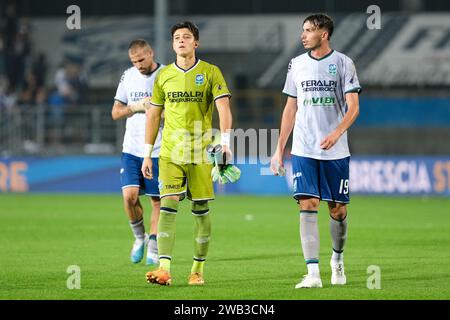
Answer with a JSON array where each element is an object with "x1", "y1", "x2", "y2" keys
[{"x1": 114, "y1": 64, "x2": 163, "y2": 158}]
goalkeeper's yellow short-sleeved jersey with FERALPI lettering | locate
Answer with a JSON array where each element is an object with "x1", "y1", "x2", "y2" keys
[{"x1": 151, "y1": 60, "x2": 231, "y2": 163}]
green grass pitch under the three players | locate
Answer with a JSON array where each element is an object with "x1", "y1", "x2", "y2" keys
[{"x1": 0, "y1": 194, "x2": 450, "y2": 300}]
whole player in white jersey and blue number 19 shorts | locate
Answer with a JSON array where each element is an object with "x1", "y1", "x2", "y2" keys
[{"x1": 271, "y1": 14, "x2": 361, "y2": 288}]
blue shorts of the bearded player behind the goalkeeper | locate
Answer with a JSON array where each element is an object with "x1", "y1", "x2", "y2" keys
[{"x1": 120, "y1": 153, "x2": 159, "y2": 197}]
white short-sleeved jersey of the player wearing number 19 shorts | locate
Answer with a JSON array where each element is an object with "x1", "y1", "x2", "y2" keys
[{"x1": 283, "y1": 50, "x2": 361, "y2": 160}]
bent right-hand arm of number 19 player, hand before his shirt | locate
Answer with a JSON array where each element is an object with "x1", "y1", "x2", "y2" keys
[{"x1": 320, "y1": 92, "x2": 359, "y2": 150}]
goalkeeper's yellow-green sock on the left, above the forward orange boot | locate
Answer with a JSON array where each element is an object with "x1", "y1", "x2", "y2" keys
[{"x1": 158, "y1": 198, "x2": 178, "y2": 271}]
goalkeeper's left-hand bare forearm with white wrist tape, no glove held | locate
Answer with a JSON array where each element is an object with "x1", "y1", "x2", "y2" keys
[{"x1": 141, "y1": 106, "x2": 163, "y2": 179}]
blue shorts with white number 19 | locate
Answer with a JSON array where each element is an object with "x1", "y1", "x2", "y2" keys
[{"x1": 292, "y1": 155, "x2": 350, "y2": 203}]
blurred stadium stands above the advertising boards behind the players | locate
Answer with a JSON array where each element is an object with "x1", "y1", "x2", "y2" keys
[{"x1": 0, "y1": 0, "x2": 450, "y2": 157}]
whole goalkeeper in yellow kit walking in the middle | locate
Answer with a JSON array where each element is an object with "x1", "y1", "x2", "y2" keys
[{"x1": 142, "y1": 21, "x2": 232, "y2": 285}]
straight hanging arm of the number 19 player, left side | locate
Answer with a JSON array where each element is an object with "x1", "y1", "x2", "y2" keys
[{"x1": 270, "y1": 96, "x2": 297, "y2": 175}]
